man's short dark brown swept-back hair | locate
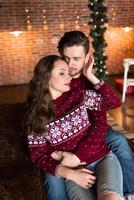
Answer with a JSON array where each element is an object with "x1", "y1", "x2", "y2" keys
[{"x1": 58, "y1": 31, "x2": 89, "y2": 55}]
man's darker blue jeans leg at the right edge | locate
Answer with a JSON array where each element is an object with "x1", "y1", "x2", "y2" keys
[{"x1": 106, "y1": 129, "x2": 134, "y2": 194}]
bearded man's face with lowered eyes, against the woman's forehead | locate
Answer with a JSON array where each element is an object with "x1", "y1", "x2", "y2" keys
[{"x1": 63, "y1": 45, "x2": 88, "y2": 78}]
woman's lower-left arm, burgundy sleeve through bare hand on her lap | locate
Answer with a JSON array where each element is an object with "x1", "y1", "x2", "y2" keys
[{"x1": 28, "y1": 136, "x2": 96, "y2": 188}]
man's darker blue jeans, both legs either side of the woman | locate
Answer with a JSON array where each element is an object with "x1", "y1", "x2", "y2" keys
[{"x1": 44, "y1": 129, "x2": 134, "y2": 200}]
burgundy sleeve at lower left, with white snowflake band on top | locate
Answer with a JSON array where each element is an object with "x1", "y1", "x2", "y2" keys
[{"x1": 28, "y1": 135, "x2": 59, "y2": 175}]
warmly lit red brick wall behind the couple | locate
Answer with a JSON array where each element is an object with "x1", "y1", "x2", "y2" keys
[{"x1": 0, "y1": 0, "x2": 134, "y2": 85}]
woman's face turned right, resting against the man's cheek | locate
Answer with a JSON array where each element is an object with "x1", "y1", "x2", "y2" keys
[{"x1": 49, "y1": 60, "x2": 71, "y2": 99}]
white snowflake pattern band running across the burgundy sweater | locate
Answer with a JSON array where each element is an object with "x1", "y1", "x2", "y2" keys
[{"x1": 28, "y1": 90, "x2": 102, "y2": 145}]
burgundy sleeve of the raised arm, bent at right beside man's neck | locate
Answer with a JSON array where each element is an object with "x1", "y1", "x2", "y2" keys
[{"x1": 94, "y1": 81, "x2": 121, "y2": 110}]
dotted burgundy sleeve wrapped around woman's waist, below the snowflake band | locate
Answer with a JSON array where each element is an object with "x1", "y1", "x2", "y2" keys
[{"x1": 74, "y1": 96, "x2": 108, "y2": 161}]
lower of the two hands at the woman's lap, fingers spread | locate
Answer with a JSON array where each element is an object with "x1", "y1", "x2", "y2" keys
[{"x1": 67, "y1": 168, "x2": 96, "y2": 189}]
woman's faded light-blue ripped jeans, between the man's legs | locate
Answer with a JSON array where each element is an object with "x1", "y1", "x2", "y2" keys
[{"x1": 65, "y1": 152, "x2": 123, "y2": 200}]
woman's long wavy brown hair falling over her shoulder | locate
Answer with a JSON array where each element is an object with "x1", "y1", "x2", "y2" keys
[{"x1": 24, "y1": 55, "x2": 61, "y2": 134}]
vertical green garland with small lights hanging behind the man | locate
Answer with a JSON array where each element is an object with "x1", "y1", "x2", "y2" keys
[{"x1": 89, "y1": 0, "x2": 108, "y2": 79}]
